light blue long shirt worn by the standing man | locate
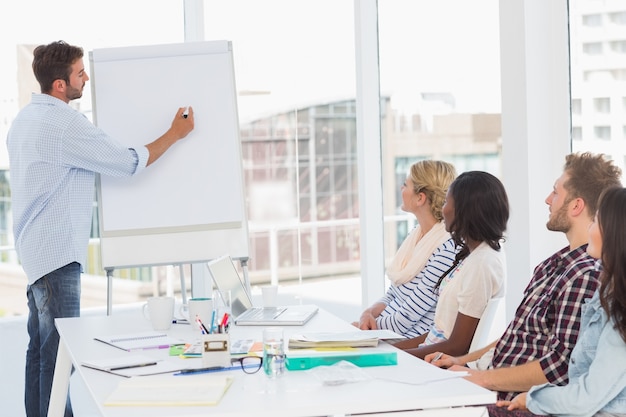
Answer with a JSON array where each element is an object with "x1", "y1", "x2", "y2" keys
[{"x1": 7, "y1": 94, "x2": 149, "y2": 284}]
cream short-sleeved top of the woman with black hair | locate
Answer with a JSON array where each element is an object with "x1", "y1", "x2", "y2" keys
[{"x1": 435, "y1": 242, "x2": 506, "y2": 339}]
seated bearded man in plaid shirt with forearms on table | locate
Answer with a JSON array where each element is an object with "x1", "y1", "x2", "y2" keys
[{"x1": 424, "y1": 153, "x2": 621, "y2": 404}]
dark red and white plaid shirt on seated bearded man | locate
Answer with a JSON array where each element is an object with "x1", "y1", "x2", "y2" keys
[{"x1": 491, "y1": 245, "x2": 600, "y2": 400}]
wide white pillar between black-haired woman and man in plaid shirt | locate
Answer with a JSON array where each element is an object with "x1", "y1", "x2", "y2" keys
[{"x1": 500, "y1": 0, "x2": 571, "y2": 319}]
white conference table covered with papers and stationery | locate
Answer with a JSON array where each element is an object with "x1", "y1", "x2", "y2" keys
[{"x1": 48, "y1": 309, "x2": 496, "y2": 417}]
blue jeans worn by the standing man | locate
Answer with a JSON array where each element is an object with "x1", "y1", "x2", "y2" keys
[{"x1": 24, "y1": 262, "x2": 81, "y2": 417}]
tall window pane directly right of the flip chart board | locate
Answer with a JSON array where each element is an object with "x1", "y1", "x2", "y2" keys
[{"x1": 205, "y1": 0, "x2": 360, "y2": 282}]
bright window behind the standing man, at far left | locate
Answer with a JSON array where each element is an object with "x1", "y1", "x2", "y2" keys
[{"x1": 0, "y1": 0, "x2": 185, "y2": 316}]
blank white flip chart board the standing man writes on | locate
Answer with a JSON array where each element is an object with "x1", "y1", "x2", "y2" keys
[{"x1": 89, "y1": 41, "x2": 249, "y2": 269}]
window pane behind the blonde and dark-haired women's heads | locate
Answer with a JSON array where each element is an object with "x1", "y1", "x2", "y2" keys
[{"x1": 378, "y1": 0, "x2": 501, "y2": 259}]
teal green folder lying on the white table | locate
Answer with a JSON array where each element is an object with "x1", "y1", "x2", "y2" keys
[{"x1": 285, "y1": 349, "x2": 398, "y2": 371}]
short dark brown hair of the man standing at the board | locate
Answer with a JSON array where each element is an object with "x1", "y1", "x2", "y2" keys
[{"x1": 33, "y1": 41, "x2": 83, "y2": 93}]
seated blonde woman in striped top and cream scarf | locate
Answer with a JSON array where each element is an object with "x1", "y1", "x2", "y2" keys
[{"x1": 353, "y1": 161, "x2": 456, "y2": 338}]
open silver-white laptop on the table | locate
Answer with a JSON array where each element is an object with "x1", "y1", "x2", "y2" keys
[{"x1": 207, "y1": 255, "x2": 318, "y2": 326}]
